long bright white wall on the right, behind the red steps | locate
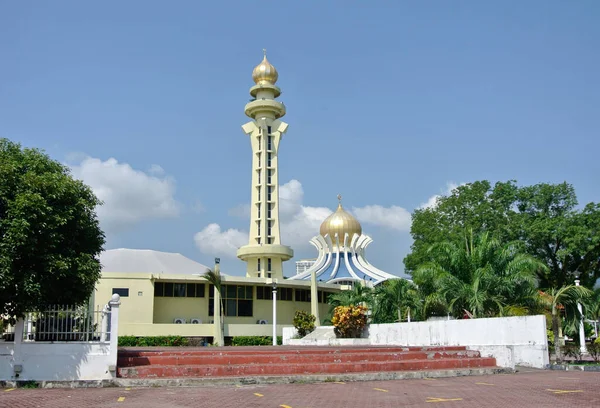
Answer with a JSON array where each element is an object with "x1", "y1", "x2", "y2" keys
[{"x1": 283, "y1": 315, "x2": 550, "y2": 368}]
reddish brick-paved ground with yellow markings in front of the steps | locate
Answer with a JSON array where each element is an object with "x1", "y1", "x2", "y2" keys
[{"x1": 0, "y1": 369, "x2": 600, "y2": 408}]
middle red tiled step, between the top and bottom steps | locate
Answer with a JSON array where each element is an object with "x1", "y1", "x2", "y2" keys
[{"x1": 118, "y1": 350, "x2": 479, "y2": 367}]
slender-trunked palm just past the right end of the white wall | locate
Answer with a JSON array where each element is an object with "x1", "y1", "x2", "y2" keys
[{"x1": 541, "y1": 285, "x2": 593, "y2": 363}]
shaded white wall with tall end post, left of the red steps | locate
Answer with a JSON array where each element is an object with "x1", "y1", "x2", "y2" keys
[{"x1": 0, "y1": 295, "x2": 120, "y2": 381}]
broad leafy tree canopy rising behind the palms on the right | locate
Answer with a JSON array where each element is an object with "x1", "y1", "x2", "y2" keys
[{"x1": 404, "y1": 180, "x2": 600, "y2": 288}]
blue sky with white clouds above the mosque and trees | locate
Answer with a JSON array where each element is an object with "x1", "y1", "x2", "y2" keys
[{"x1": 0, "y1": 0, "x2": 600, "y2": 275}]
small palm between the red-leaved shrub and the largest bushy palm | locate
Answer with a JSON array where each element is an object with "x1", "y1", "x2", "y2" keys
[{"x1": 373, "y1": 279, "x2": 421, "y2": 323}]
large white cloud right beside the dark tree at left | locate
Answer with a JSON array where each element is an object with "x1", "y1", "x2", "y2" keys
[{"x1": 71, "y1": 157, "x2": 180, "y2": 232}]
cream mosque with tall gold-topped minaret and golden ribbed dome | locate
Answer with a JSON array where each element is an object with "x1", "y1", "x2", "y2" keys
[{"x1": 94, "y1": 51, "x2": 399, "y2": 344}]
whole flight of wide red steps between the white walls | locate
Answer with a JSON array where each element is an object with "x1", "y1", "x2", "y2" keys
[{"x1": 117, "y1": 346, "x2": 496, "y2": 379}]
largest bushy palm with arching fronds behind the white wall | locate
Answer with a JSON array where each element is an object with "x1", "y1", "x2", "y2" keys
[{"x1": 413, "y1": 232, "x2": 546, "y2": 317}]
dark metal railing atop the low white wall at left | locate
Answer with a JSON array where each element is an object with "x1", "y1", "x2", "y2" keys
[{"x1": 18, "y1": 305, "x2": 110, "y2": 342}]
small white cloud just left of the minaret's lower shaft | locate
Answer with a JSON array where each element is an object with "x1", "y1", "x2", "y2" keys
[{"x1": 194, "y1": 224, "x2": 248, "y2": 257}]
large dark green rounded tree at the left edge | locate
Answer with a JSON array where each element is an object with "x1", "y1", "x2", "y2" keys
[{"x1": 0, "y1": 139, "x2": 104, "y2": 320}]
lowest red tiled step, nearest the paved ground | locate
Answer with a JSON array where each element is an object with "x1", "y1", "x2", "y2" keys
[{"x1": 118, "y1": 357, "x2": 496, "y2": 378}]
